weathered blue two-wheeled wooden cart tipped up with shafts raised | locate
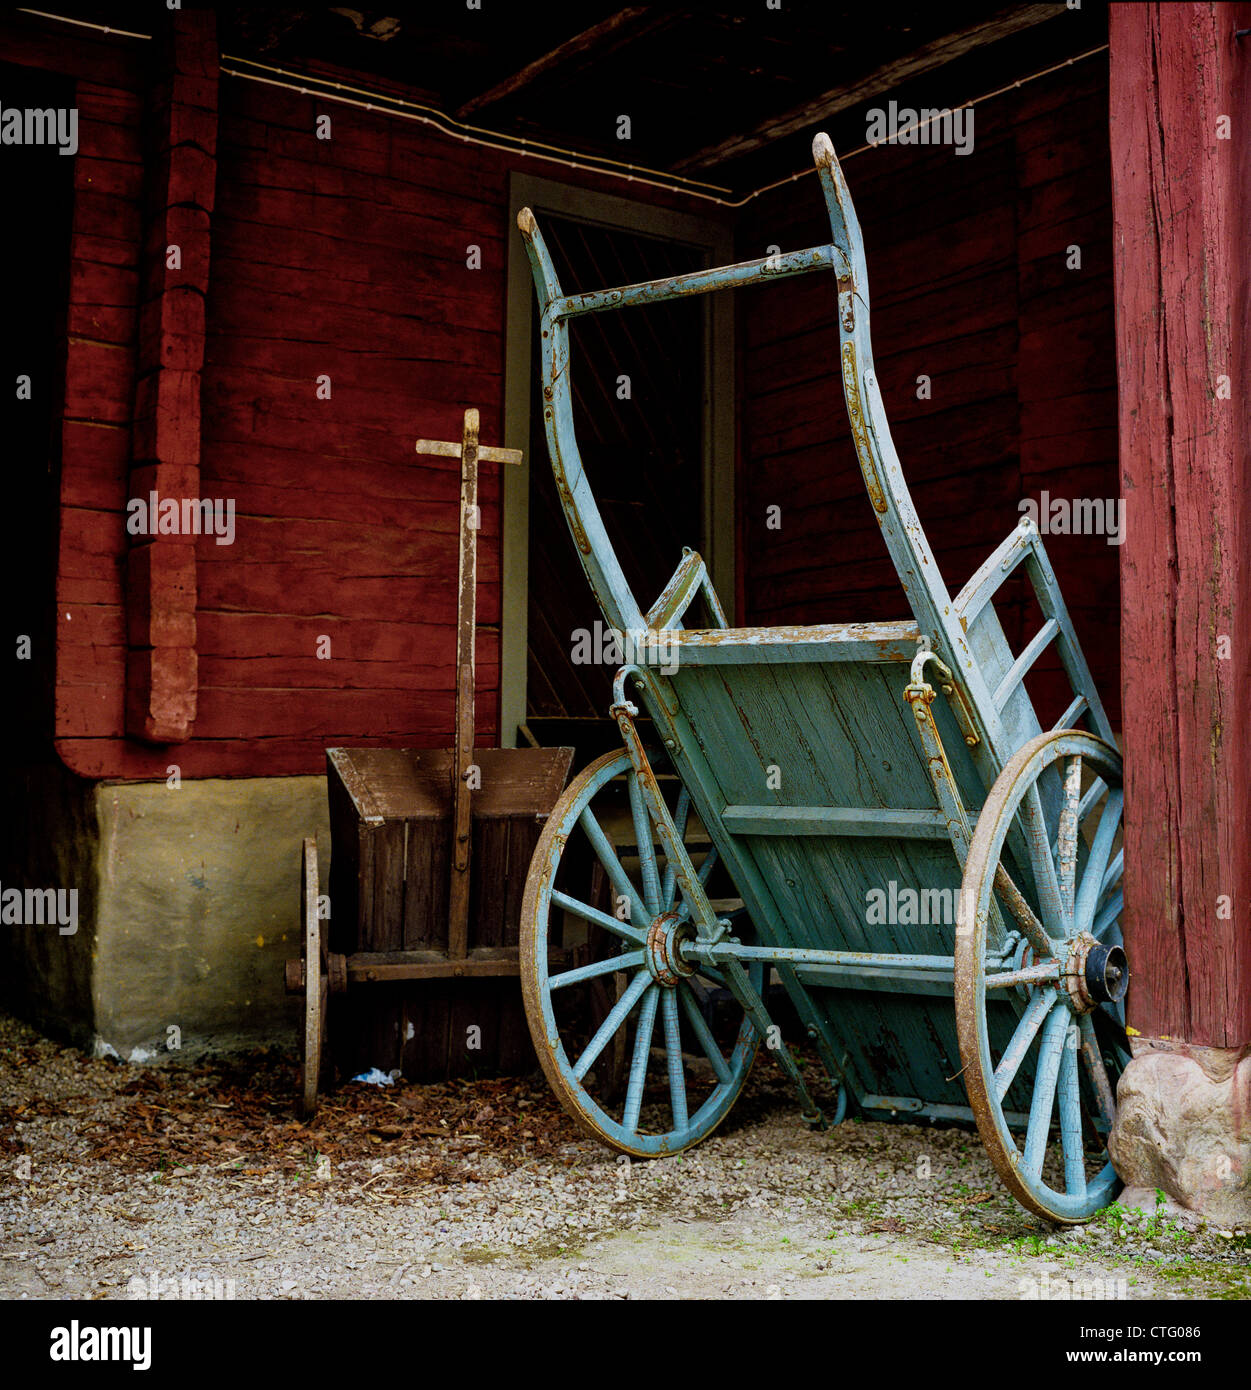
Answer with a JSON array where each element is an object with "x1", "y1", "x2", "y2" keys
[{"x1": 518, "y1": 135, "x2": 1129, "y2": 1222}]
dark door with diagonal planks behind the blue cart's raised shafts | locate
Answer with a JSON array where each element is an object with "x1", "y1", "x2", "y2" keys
[{"x1": 527, "y1": 214, "x2": 706, "y2": 741}]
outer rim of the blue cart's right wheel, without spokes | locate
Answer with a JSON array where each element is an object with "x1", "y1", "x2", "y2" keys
[{"x1": 955, "y1": 730, "x2": 1122, "y2": 1223}]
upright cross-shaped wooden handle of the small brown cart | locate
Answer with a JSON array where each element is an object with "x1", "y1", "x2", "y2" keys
[{"x1": 417, "y1": 410, "x2": 523, "y2": 960}]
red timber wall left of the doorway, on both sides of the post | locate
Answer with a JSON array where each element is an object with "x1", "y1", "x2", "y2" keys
[{"x1": 12, "y1": 19, "x2": 688, "y2": 778}]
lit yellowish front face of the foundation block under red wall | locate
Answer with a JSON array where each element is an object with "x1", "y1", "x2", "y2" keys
[{"x1": 92, "y1": 777, "x2": 329, "y2": 1062}]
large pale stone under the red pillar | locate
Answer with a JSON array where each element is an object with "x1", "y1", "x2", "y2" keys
[{"x1": 1108, "y1": 1038, "x2": 1251, "y2": 1227}]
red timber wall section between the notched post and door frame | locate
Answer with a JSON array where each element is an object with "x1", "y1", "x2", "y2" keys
[{"x1": 196, "y1": 70, "x2": 507, "y2": 770}]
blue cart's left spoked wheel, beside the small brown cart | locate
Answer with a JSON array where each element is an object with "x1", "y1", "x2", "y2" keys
[{"x1": 521, "y1": 751, "x2": 763, "y2": 1158}]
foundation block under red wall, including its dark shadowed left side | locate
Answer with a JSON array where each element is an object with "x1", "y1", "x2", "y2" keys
[{"x1": 0, "y1": 765, "x2": 331, "y2": 1063}]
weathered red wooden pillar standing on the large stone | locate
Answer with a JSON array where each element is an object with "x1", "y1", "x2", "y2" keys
[{"x1": 1109, "y1": 3, "x2": 1251, "y2": 1048}]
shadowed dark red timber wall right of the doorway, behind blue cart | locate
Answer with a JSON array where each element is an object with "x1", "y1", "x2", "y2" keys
[{"x1": 739, "y1": 54, "x2": 1119, "y2": 723}]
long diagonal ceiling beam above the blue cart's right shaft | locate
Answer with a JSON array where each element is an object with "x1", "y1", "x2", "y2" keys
[{"x1": 670, "y1": 3, "x2": 1066, "y2": 174}]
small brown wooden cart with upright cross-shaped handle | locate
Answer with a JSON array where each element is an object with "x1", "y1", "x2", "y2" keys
[{"x1": 285, "y1": 409, "x2": 573, "y2": 1115}]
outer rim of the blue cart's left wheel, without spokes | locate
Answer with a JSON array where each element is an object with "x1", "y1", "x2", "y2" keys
[{"x1": 521, "y1": 751, "x2": 762, "y2": 1158}]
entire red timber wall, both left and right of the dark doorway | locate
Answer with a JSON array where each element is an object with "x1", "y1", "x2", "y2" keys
[{"x1": 6, "y1": 18, "x2": 1118, "y2": 777}]
